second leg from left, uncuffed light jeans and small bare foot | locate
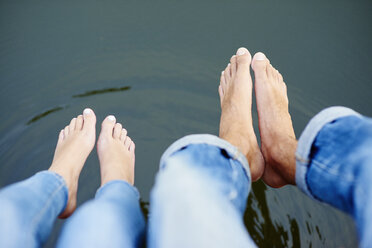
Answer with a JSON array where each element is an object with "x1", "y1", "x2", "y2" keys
[{"x1": 58, "y1": 116, "x2": 145, "y2": 247}]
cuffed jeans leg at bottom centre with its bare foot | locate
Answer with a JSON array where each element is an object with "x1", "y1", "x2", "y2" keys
[{"x1": 148, "y1": 48, "x2": 258, "y2": 248}]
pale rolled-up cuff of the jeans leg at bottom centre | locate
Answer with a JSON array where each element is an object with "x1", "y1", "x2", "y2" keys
[{"x1": 160, "y1": 134, "x2": 251, "y2": 182}]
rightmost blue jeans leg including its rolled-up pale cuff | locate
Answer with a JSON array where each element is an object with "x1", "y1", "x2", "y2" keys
[{"x1": 296, "y1": 108, "x2": 372, "y2": 247}]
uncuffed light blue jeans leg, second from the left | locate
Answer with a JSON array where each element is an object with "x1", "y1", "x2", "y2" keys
[{"x1": 57, "y1": 180, "x2": 145, "y2": 248}]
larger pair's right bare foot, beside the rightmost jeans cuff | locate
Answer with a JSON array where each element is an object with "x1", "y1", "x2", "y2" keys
[{"x1": 252, "y1": 53, "x2": 297, "y2": 188}]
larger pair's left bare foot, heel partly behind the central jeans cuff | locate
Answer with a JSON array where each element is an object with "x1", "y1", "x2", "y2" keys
[{"x1": 218, "y1": 48, "x2": 265, "y2": 181}]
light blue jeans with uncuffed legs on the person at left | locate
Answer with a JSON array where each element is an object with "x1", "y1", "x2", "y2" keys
[{"x1": 0, "y1": 171, "x2": 145, "y2": 248}]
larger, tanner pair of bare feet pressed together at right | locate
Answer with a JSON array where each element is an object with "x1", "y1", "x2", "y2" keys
[{"x1": 218, "y1": 47, "x2": 297, "y2": 188}]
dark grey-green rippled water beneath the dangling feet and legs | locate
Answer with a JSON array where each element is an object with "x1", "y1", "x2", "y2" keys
[{"x1": 0, "y1": 0, "x2": 372, "y2": 247}]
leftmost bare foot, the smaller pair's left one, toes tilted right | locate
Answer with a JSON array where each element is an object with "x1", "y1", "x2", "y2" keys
[{"x1": 49, "y1": 109, "x2": 96, "y2": 218}]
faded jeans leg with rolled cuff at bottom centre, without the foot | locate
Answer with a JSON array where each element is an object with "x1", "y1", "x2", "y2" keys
[{"x1": 148, "y1": 135, "x2": 256, "y2": 248}]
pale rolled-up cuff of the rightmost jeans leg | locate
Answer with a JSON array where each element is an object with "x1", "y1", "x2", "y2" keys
[{"x1": 296, "y1": 106, "x2": 362, "y2": 199}]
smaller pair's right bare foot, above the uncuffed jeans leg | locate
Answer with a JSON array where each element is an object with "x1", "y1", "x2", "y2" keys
[{"x1": 97, "y1": 115, "x2": 135, "y2": 186}]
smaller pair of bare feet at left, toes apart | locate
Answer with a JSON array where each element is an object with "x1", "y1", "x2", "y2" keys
[{"x1": 49, "y1": 109, "x2": 135, "y2": 218}]
